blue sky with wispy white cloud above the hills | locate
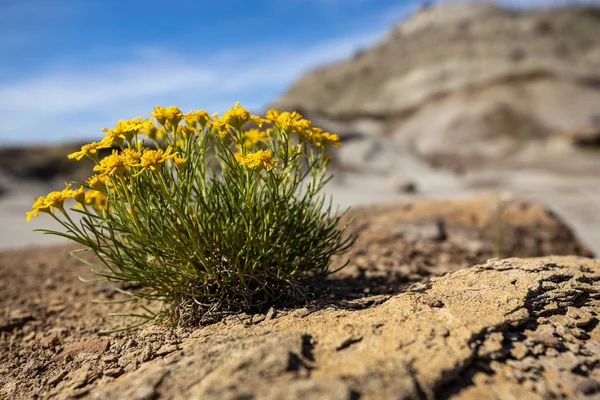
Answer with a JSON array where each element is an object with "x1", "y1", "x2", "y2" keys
[{"x1": 0, "y1": 0, "x2": 597, "y2": 145}]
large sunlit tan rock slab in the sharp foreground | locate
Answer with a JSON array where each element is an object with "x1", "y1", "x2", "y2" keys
[{"x1": 92, "y1": 257, "x2": 600, "y2": 399}]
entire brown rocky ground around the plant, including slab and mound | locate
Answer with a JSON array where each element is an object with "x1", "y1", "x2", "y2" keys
[{"x1": 0, "y1": 196, "x2": 600, "y2": 399}]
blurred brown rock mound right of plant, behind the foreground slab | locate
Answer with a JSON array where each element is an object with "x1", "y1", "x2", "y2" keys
[{"x1": 328, "y1": 194, "x2": 592, "y2": 296}]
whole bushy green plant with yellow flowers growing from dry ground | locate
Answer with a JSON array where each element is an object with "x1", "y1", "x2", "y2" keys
[{"x1": 27, "y1": 103, "x2": 354, "y2": 326}]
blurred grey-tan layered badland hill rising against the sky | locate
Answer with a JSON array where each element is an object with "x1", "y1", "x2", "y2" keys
[{"x1": 272, "y1": 4, "x2": 600, "y2": 170}]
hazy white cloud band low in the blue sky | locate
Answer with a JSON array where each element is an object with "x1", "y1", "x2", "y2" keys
[{"x1": 0, "y1": 21, "x2": 387, "y2": 144}]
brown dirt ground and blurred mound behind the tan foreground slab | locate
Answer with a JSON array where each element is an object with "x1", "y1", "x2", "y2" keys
[{"x1": 0, "y1": 196, "x2": 591, "y2": 399}]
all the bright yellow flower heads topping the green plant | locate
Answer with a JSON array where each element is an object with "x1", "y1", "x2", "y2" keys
[{"x1": 27, "y1": 102, "x2": 340, "y2": 221}]
